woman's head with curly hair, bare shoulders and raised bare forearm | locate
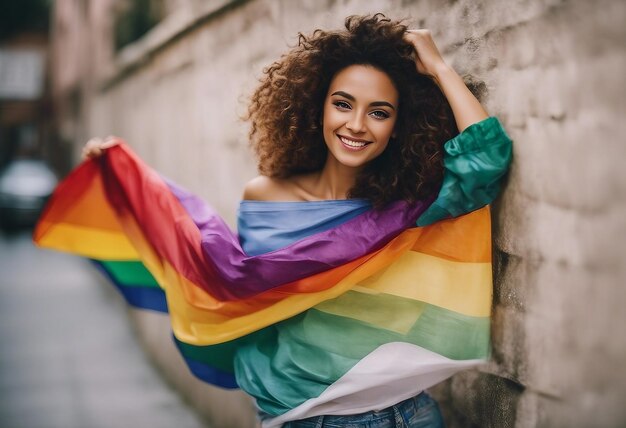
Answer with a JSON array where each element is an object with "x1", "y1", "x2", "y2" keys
[{"x1": 244, "y1": 15, "x2": 487, "y2": 208}]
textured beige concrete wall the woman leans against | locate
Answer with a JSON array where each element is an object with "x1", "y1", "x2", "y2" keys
[{"x1": 54, "y1": 0, "x2": 626, "y2": 427}]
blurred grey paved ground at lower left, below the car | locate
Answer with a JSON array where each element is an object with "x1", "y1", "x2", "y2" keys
[{"x1": 0, "y1": 232, "x2": 210, "y2": 428}]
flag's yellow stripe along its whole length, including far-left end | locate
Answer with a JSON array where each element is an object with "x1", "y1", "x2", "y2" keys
[{"x1": 39, "y1": 201, "x2": 491, "y2": 345}]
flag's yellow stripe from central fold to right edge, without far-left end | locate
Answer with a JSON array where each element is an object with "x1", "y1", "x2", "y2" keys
[{"x1": 136, "y1": 224, "x2": 491, "y2": 345}]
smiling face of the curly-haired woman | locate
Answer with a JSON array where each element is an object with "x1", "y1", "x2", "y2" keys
[{"x1": 322, "y1": 65, "x2": 398, "y2": 168}]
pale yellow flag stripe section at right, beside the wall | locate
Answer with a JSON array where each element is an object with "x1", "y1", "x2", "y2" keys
[{"x1": 354, "y1": 251, "x2": 492, "y2": 317}]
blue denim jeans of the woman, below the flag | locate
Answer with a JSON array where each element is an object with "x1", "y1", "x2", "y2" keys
[{"x1": 283, "y1": 392, "x2": 444, "y2": 428}]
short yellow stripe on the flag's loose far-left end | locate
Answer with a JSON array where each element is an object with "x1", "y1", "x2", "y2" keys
[{"x1": 37, "y1": 223, "x2": 139, "y2": 260}]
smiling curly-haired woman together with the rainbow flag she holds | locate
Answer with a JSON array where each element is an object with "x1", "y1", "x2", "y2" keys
[{"x1": 45, "y1": 14, "x2": 511, "y2": 428}]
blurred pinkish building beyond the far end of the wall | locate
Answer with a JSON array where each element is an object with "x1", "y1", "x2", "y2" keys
[{"x1": 50, "y1": 0, "x2": 165, "y2": 174}]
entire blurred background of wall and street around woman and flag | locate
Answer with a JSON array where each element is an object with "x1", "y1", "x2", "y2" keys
[{"x1": 0, "y1": 0, "x2": 626, "y2": 428}]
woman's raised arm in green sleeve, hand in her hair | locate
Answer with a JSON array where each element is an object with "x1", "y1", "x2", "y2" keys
[{"x1": 405, "y1": 30, "x2": 512, "y2": 226}]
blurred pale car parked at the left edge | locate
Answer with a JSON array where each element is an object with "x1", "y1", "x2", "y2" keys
[{"x1": 0, "y1": 159, "x2": 58, "y2": 227}]
